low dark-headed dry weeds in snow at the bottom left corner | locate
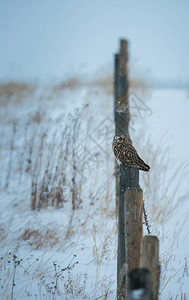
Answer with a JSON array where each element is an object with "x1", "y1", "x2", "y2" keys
[{"x1": 0, "y1": 253, "x2": 87, "y2": 300}]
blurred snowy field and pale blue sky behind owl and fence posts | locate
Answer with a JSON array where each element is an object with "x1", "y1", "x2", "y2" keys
[{"x1": 0, "y1": 0, "x2": 189, "y2": 300}]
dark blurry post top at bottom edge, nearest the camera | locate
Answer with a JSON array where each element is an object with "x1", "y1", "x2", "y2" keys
[{"x1": 127, "y1": 268, "x2": 152, "y2": 300}]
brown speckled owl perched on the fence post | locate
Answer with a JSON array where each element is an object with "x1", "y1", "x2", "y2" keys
[{"x1": 112, "y1": 134, "x2": 150, "y2": 171}]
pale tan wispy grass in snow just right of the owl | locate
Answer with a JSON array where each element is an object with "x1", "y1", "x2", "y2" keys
[{"x1": 141, "y1": 134, "x2": 188, "y2": 223}]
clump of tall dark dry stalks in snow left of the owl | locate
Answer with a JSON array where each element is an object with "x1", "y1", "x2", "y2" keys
[{"x1": 30, "y1": 108, "x2": 86, "y2": 210}]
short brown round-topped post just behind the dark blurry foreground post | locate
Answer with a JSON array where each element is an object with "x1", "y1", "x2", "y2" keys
[{"x1": 140, "y1": 235, "x2": 159, "y2": 300}]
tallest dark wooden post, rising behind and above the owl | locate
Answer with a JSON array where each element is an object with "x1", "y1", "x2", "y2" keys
[{"x1": 114, "y1": 39, "x2": 130, "y2": 210}]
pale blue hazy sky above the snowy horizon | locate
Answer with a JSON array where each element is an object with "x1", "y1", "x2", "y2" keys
[{"x1": 0, "y1": 0, "x2": 189, "y2": 81}]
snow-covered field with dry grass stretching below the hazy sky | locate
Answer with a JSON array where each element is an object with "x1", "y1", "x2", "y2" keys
[{"x1": 0, "y1": 81, "x2": 189, "y2": 300}]
